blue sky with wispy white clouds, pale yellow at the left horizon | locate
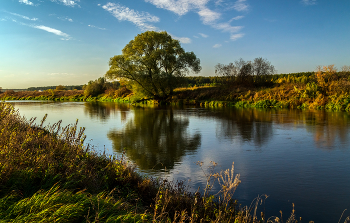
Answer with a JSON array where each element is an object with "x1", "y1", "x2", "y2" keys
[{"x1": 0, "y1": 0, "x2": 350, "y2": 89}]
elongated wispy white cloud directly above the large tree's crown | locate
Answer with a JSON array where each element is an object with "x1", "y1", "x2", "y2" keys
[{"x1": 102, "y1": 2, "x2": 159, "y2": 30}]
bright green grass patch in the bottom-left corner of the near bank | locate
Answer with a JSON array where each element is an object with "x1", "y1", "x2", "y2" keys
[{"x1": 0, "y1": 185, "x2": 141, "y2": 222}]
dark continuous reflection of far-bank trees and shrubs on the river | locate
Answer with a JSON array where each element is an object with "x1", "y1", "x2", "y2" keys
[{"x1": 84, "y1": 103, "x2": 350, "y2": 171}]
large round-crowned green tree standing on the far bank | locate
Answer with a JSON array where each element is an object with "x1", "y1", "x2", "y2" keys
[{"x1": 105, "y1": 31, "x2": 201, "y2": 101}]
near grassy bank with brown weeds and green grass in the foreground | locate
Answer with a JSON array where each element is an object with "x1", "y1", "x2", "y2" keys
[{"x1": 0, "y1": 103, "x2": 295, "y2": 222}]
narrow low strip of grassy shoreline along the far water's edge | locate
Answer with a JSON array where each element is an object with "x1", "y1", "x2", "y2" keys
[{"x1": 0, "y1": 89, "x2": 350, "y2": 112}]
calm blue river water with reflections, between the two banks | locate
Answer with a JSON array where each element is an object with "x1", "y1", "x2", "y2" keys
[{"x1": 7, "y1": 101, "x2": 350, "y2": 222}]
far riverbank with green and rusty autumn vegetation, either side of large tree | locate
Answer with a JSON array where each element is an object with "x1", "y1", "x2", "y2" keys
[{"x1": 0, "y1": 73, "x2": 350, "y2": 111}]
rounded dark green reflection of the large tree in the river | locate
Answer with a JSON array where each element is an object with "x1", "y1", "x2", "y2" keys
[{"x1": 108, "y1": 108, "x2": 201, "y2": 170}]
